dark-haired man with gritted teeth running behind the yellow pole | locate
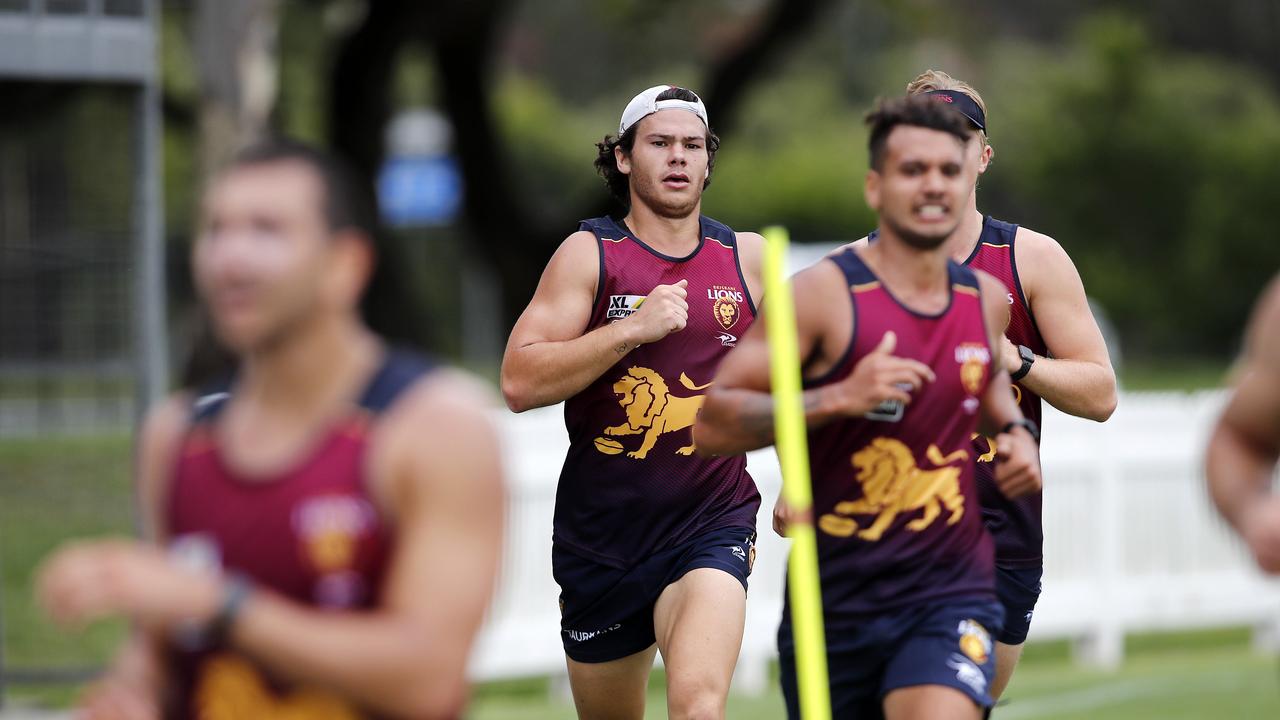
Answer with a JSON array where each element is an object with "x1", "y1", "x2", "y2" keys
[{"x1": 694, "y1": 97, "x2": 1041, "y2": 720}]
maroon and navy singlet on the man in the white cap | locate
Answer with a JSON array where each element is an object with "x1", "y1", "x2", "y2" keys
[{"x1": 553, "y1": 212, "x2": 760, "y2": 569}]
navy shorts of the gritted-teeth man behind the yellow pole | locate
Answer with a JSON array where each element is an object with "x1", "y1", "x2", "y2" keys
[{"x1": 778, "y1": 598, "x2": 1001, "y2": 720}]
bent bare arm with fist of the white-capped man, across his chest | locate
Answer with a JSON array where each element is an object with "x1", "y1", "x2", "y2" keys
[{"x1": 502, "y1": 231, "x2": 689, "y2": 413}]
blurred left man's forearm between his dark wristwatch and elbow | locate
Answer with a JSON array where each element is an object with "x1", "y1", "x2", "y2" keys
[{"x1": 230, "y1": 592, "x2": 466, "y2": 717}]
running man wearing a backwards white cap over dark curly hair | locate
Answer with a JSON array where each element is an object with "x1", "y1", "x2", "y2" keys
[{"x1": 502, "y1": 86, "x2": 763, "y2": 720}]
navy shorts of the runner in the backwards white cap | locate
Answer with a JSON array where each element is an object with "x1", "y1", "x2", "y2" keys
[{"x1": 552, "y1": 520, "x2": 755, "y2": 662}]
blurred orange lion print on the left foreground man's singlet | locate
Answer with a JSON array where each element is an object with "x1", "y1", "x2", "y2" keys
[{"x1": 192, "y1": 653, "x2": 364, "y2": 720}]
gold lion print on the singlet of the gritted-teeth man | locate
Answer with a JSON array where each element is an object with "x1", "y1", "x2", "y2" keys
[{"x1": 818, "y1": 437, "x2": 969, "y2": 542}]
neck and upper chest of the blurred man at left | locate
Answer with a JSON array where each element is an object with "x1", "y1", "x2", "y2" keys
[{"x1": 237, "y1": 316, "x2": 381, "y2": 415}]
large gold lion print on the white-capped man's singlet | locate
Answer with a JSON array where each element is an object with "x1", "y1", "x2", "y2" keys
[{"x1": 595, "y1": 366, "x2": 710, "y2": 460}]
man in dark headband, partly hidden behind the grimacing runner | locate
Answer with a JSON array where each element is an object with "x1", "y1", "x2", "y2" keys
[{"x1": 774, "y1": 70, "x2": 1116, "y2": 700}]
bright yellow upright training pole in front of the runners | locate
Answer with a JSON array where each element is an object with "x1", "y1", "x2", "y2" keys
[{"x1": 764, "y1": 225, "x2": 831, "y2": 720}]
